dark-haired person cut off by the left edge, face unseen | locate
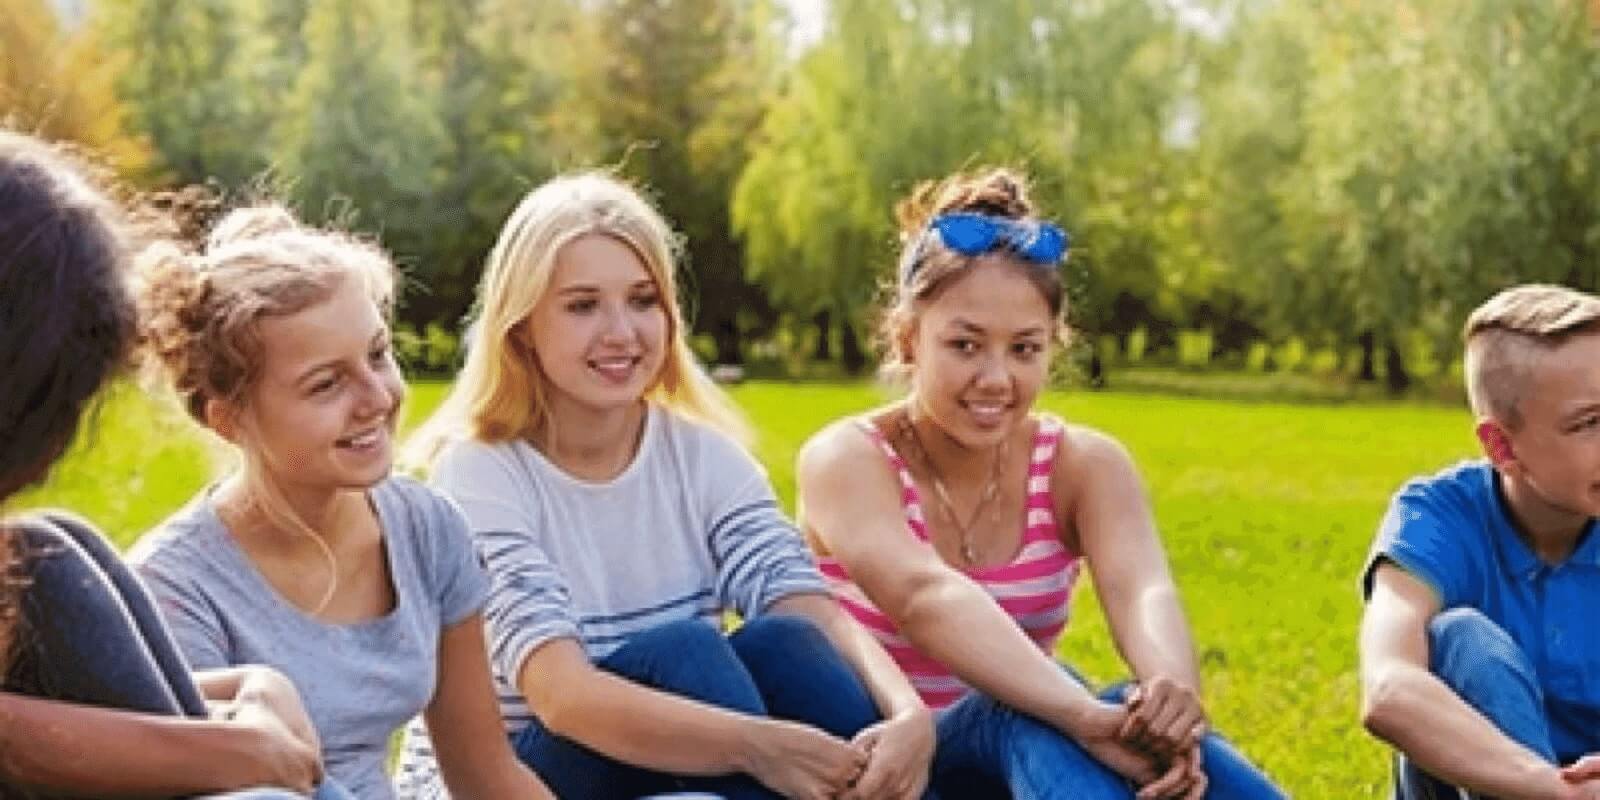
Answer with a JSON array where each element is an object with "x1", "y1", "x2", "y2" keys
[{"x1": 0, "y1": 131, "x2": 331, "y2": 798}]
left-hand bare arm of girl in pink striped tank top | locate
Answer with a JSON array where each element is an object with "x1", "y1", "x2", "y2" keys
[{"x1": 797, "y1": 424, "x2": 1150, "y2": 779}]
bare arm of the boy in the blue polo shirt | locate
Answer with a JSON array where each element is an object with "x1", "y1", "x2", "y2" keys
[{"x1": 1360, "y1": 563, "x2": 1578, "y2": 800}]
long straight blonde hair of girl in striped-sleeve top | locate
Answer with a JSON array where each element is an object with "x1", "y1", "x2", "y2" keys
[{"x1": 402, "y1": 171, "x2": 752, "y2": 470}]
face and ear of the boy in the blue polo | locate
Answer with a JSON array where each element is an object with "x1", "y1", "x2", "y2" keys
[{"x1": 1478, "y1": 333, "x2": 1600, "y2": 528}]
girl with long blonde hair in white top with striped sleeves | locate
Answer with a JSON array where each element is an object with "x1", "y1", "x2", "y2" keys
[{"x1": 392, "y1": 173, "x2": 931, "y2": 798}]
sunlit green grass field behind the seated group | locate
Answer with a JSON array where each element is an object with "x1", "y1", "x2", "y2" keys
[{"x1": 13, "y1": 382, "x2": 1475, "y2": 798}]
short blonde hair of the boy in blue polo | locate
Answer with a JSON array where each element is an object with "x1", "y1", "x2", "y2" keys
[{"x1": 1462, "y1": 283, "x2": 1600, "y2": 429}]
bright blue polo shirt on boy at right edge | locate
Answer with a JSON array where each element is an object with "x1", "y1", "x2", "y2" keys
[{"x1": 1362, "y1": 461, "x2": 1600, "y2": 763}]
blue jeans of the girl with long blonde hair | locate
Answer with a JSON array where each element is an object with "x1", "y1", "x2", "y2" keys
[{"x1": 512, "y1": 614, "x2": 880, "y2": 800}]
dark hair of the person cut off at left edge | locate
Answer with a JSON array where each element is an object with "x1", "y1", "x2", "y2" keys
[{"x1": 0, "y1": 131, "x2": 136, "y2": 668}]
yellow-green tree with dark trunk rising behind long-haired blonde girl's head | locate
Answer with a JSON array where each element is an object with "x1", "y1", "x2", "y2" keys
[{"x1": 565, "y1": 0, "x2": 779, "y2": 363}]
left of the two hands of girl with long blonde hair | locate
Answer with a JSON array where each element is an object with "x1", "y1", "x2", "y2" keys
[{"x1": 744, "y1": 720, "x2": 867, "y2": 800}]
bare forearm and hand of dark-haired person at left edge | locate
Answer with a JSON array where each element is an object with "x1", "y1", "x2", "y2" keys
[{"x1": 0, "y1": 693, "x2": 322, "y2": 797}]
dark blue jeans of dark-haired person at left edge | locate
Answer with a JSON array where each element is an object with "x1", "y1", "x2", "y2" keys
[{"x1": 6, "y1": 514, "x2": 350, "y2": 800}]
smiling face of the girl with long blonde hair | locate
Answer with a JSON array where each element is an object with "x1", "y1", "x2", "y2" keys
[{"x1": 523, "y1": 234, "x2": 669, "y2": 419}]
